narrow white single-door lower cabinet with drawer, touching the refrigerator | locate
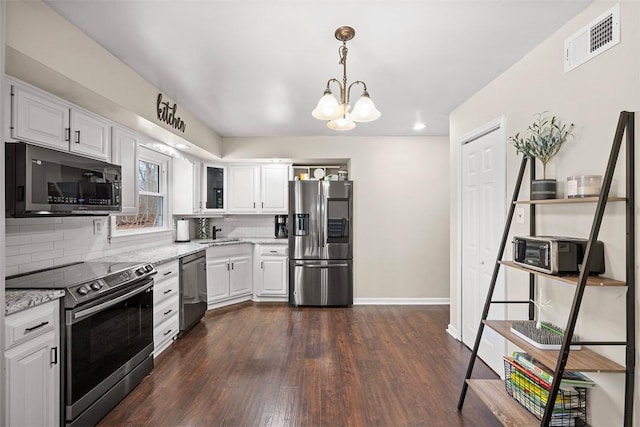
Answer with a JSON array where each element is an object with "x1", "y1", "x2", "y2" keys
[{"x1": 254, "y1": 245, "x2": 289, "y2": 301}]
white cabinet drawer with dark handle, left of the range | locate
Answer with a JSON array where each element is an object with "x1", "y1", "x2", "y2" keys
[{"x1": 5, "y1": 300, "x2": 60, "y2": 350}]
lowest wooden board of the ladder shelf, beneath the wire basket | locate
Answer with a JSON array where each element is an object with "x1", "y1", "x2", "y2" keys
[{"x1": 467, "y1": 380, "x2": 540, "y2": 427}]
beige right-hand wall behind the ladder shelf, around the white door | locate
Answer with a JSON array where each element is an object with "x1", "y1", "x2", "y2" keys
[{"x1": 449, "y1": 2, "x2": 640, "y2": 427}]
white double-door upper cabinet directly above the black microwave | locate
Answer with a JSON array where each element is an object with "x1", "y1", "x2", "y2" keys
[{"x1": 11, "y1": 85, "x2": 111, "y2": 161}]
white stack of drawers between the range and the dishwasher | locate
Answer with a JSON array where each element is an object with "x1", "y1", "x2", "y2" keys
[{"x1": 153, "y1": 260, "x2": 180, "y2": 357}]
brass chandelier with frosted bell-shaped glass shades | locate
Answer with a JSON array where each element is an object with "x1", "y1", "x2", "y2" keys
[{"x1": 311, "y1": 27, "x2": 381, "y2": 131}]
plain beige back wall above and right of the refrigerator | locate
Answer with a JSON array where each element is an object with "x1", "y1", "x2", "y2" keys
[{"x1": 223, "y1": 136, "x2": 449, "y2": 303}]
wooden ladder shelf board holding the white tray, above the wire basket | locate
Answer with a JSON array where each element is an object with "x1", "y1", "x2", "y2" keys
[{"x1": 484, "y1": 320, "x2": 625, "y2": 372}]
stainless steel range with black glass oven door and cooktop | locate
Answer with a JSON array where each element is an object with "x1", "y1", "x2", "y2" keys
[{"x1": 6, "y1": 262, "x2": 156, "y2": 426}]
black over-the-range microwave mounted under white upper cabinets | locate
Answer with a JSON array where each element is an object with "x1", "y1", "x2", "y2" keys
[{"x1": 5, "y1": 142, "x2": 122, "y2": 217}]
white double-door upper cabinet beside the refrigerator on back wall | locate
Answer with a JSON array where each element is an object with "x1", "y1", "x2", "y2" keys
[{"x1": 229, "y1": 164, "x2": 290, "y2": 213}]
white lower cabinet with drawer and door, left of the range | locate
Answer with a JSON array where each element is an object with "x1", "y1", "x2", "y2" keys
[{"x1": 3, "y1": 300, "x2": 61, "y2": 426}]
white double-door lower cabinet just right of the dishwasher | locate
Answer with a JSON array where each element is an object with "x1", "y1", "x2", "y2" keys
[{"x1": 207, "y1": 244, "x2": 253, "y2": 308}]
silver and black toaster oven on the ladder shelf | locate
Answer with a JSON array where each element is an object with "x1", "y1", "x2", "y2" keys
[{"x1": 513, "y1": 236, "x2": 605, "y2": 275}]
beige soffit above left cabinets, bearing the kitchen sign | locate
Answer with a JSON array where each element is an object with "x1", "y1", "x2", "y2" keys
[{"x1": 3, "y1": 0, "x2": 222, "y2": 157}]
